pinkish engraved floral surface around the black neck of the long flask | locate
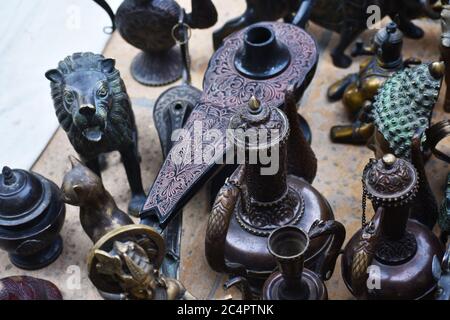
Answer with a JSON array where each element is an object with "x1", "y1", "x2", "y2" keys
[{"x1": 143, "y1": 22, "x2": 318, "y2": 222}]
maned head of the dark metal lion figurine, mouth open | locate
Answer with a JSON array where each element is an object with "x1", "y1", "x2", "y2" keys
[{"x1": 45, "y1": 52, "x2": 135, "y2": 156}]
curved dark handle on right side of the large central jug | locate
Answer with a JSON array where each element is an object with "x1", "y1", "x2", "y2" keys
[{"x1": 308, "y1": 220, "x2": 345, "y2": 281}]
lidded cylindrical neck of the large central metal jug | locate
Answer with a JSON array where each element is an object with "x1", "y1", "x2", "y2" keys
[{"x1": 230, "y1": 98, "x2": 289, "y2": 204}]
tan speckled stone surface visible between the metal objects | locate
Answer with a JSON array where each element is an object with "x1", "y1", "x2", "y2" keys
[{"x1": 0, "y1": 0, "x2": 450, "y2": 299}]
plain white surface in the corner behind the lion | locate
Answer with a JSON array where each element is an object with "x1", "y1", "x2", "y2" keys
[{"x1": 0, "y1": 0, "x2": 121, "y2": 169}]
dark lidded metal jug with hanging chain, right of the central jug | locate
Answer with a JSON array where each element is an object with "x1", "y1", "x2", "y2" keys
[{"x1": 341, "y1": 154, "x2": 444, "y2": 300}]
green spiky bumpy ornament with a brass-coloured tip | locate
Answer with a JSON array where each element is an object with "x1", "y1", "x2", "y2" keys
[{"x1": 371, "y1": 62, "x2": 444, "y2": 159}]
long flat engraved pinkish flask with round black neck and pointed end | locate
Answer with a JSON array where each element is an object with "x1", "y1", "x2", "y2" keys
[{"x1": 141, "y1": 23, "x2": 318, "y2": 226}]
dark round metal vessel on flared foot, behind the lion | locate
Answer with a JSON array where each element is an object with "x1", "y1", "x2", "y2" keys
[{"x1": 116, "y1": 0, "x2": 217, "y2": 86}]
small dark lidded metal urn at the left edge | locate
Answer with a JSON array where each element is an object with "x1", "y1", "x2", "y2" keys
[{"x1": 0, "y1": 167, "x2": 66, "y2": 270}]
